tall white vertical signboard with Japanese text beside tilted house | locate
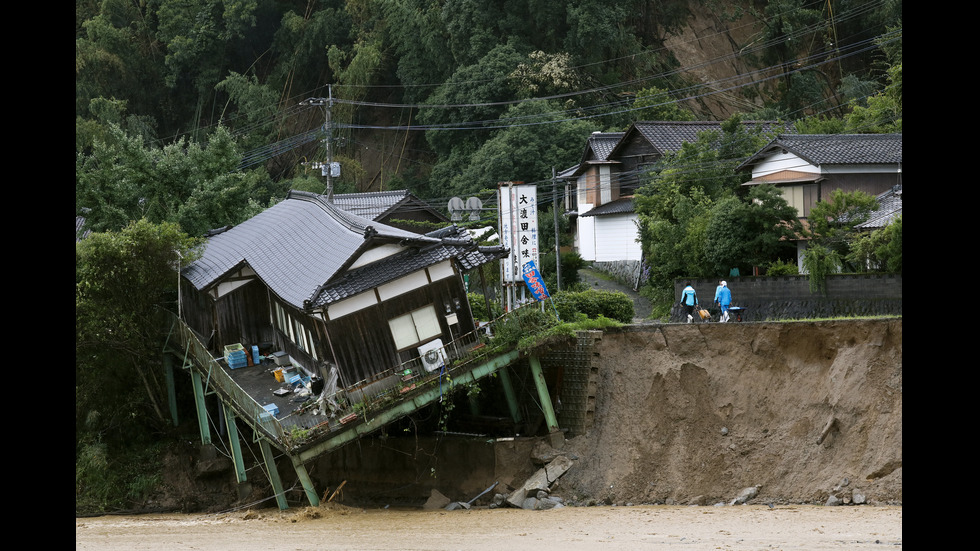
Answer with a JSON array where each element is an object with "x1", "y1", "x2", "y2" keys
[{"x1": 498, "y1": 182, "x2": 540, "y2": 283}]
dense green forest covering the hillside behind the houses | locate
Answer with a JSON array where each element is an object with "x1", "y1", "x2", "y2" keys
[{"x1": 75, "y1": 0, "x2": 902, "y2": 235}]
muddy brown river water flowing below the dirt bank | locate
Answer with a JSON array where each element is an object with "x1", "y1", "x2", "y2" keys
[{"x1": 75, "y1": 505, "x2": 902, "y2": 551}]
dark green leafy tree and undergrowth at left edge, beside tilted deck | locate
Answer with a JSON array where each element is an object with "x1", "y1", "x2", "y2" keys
[{"x1": 75, "y1": 220, "x2": 198, "y2": 510}]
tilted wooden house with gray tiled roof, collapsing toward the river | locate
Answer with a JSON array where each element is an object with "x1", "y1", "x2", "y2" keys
[{"x1": 181, "y1": 191, "x2": 507, "y2": 402}]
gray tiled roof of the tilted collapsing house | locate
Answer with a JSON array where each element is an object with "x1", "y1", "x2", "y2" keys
[{"x1": 182, "y1": 191, "x2": 506, "y2": 308}]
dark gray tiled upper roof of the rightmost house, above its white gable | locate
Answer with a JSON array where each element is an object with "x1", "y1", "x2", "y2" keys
[{"x1": 739, "y1": 134, "x2": 902, "y2": 168}]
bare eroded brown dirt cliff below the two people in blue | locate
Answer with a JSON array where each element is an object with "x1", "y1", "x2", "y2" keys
[{"x1": 559, "y1": 319, "x2": 902, "y2": 504}]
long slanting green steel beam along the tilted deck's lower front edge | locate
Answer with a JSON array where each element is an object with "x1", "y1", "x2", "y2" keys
[{"x1": 296, "y1": 350, "x2": 520, "y2": 463}]
